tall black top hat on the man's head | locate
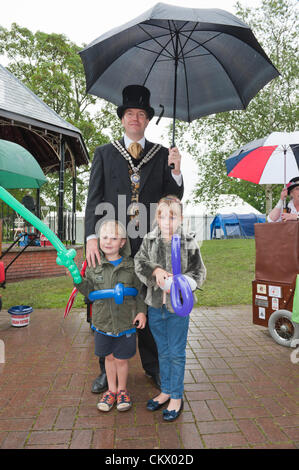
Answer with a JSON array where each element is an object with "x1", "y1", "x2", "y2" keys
[{"x1": 117, "y1": 85, "x2": 155, "y2": 120}]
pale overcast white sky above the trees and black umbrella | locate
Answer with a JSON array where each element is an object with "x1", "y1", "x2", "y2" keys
[{"x1": 0, "y1": 0, "x2": 260, "y2": 200}]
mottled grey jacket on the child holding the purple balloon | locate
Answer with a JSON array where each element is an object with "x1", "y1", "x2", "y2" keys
[{"x1": 134, "y1": 227, "x2": 206, "y2": 312}]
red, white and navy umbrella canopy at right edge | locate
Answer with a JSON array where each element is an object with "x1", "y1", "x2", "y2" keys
[{"x1": 225, "y1": 131, "x2": 299, "y2": 185}]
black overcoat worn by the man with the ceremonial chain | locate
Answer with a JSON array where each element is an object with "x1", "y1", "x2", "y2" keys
[{"x1": 85, "y1": 139, "x2": 184, "y2": 256}]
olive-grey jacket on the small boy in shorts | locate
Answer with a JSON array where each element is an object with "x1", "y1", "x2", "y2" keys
[{"x1": 75, "y1": 240, "x2": 147, "y2": 334}]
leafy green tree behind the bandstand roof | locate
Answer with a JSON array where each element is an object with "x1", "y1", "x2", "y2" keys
[{"x1": 0, "y1": 23, "x2": 119, "y2": 209}]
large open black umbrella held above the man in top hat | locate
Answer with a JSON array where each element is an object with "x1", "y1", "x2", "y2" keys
[{"x1": 80, "y1": 3, "x2": 279, "y2": 145}]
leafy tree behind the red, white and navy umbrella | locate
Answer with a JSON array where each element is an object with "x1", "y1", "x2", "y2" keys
[{"x1": 177, "y1": 0, "x2": 298, "y2": 213}]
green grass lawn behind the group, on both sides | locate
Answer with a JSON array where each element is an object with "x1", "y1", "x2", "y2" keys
[{"x1": 0, "y1": 240, "x2": 255, "y2": 310}]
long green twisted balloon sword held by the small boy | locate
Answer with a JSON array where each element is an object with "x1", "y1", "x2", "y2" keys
[{"x1": 0, "y1": 186, "x2": 82, "y2": 284}]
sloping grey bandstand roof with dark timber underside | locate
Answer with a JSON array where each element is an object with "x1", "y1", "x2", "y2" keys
[{"x1": 0, "y1": 65, "x2": 89, "y2": 173}]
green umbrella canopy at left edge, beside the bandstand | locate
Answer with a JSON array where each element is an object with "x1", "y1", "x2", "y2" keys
[{"x1": 0, "y1": 139, "x2": 47, "y2": 189}]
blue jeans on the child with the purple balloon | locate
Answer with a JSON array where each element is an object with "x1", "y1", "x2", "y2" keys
[{"x1": 148, "y1": 305, "x2": 189, "y2": 399}]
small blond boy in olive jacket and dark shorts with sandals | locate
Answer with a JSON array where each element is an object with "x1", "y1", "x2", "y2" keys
[{"x1": 76, "y1": 220, "x2": 146, "y2": 411}]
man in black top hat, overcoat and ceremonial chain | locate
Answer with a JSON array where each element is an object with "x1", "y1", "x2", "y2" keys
[{"x1": 85, "y1": 85, "x2": 184, "y2": 393}]
